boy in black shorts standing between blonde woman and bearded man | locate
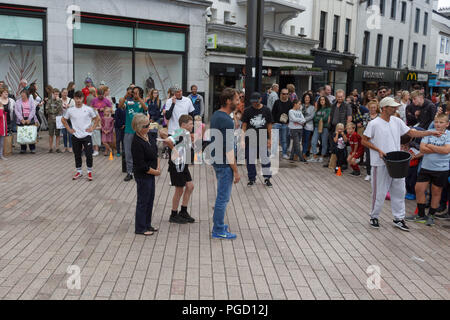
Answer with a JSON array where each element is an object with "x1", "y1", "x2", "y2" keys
[{"x1": 164, "y1": 114, "x2": 195, "y2": 224}]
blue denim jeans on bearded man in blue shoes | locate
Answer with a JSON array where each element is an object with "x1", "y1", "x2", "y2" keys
[{"x1": 212, "y1": 166, "x2": 233, "y2": 233}]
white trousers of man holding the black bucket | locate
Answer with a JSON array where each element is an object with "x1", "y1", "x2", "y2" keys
[{"x1": 370, "y1": 166, "x2": 406, "y2": 220}]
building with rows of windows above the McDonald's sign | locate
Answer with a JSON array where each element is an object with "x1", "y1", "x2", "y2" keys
[{"x1": 353, "y1": 0, "x2": 432, "y2": 91}]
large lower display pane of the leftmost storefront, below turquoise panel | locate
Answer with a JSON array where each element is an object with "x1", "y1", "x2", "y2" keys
[{"x1": 0, "y1": 44, "x2": 44, "y2": 97}]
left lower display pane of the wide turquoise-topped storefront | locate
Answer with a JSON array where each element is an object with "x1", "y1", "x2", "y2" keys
[{"x1": 74, "y1": 48, "x2": 132, "y2": 99}]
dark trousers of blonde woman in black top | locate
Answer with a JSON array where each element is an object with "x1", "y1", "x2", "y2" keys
[{"x1": 134, "y1": 175, "x2": 155, "y2": 233}]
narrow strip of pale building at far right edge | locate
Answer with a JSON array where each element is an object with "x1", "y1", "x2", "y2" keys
[{"x1": 428, "y1": 1, "x2": 450, "y2": 91}]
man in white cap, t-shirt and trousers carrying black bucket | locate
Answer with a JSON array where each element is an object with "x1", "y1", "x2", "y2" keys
[{"x1": 362, "y1": 97, "x2": 440, "y2": 231}]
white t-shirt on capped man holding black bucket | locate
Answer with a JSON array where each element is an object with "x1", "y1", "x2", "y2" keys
[{"x1": 364, "y1": 116, "x2": 411, "y2": 167}]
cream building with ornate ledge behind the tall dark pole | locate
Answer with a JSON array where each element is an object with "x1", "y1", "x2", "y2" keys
[{"x1": 206, "y1": 0, "x2": 318, "y2": 119}]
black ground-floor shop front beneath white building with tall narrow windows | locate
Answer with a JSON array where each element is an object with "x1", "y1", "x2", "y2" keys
[{"x1": 312, "y1": 49, "x2": 355, "y2": 93}]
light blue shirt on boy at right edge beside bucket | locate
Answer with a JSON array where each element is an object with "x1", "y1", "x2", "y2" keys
[{"x1": 422, "y1": 130, "x2": 450, "y2": 171}]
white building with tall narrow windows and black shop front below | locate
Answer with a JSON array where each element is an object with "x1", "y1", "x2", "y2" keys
[{"x1": 312, "y1": 0, "x2": 359, "y2": 91}]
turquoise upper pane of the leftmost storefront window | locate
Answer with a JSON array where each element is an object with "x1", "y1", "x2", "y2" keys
[{"x1": 0, "y1": 15, "x2": 43, "y2": 41}]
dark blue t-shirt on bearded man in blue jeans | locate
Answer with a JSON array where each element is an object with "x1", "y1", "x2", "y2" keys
[{"x1": 210, "y1": 110, "x2": 234, "y2": 167}]
